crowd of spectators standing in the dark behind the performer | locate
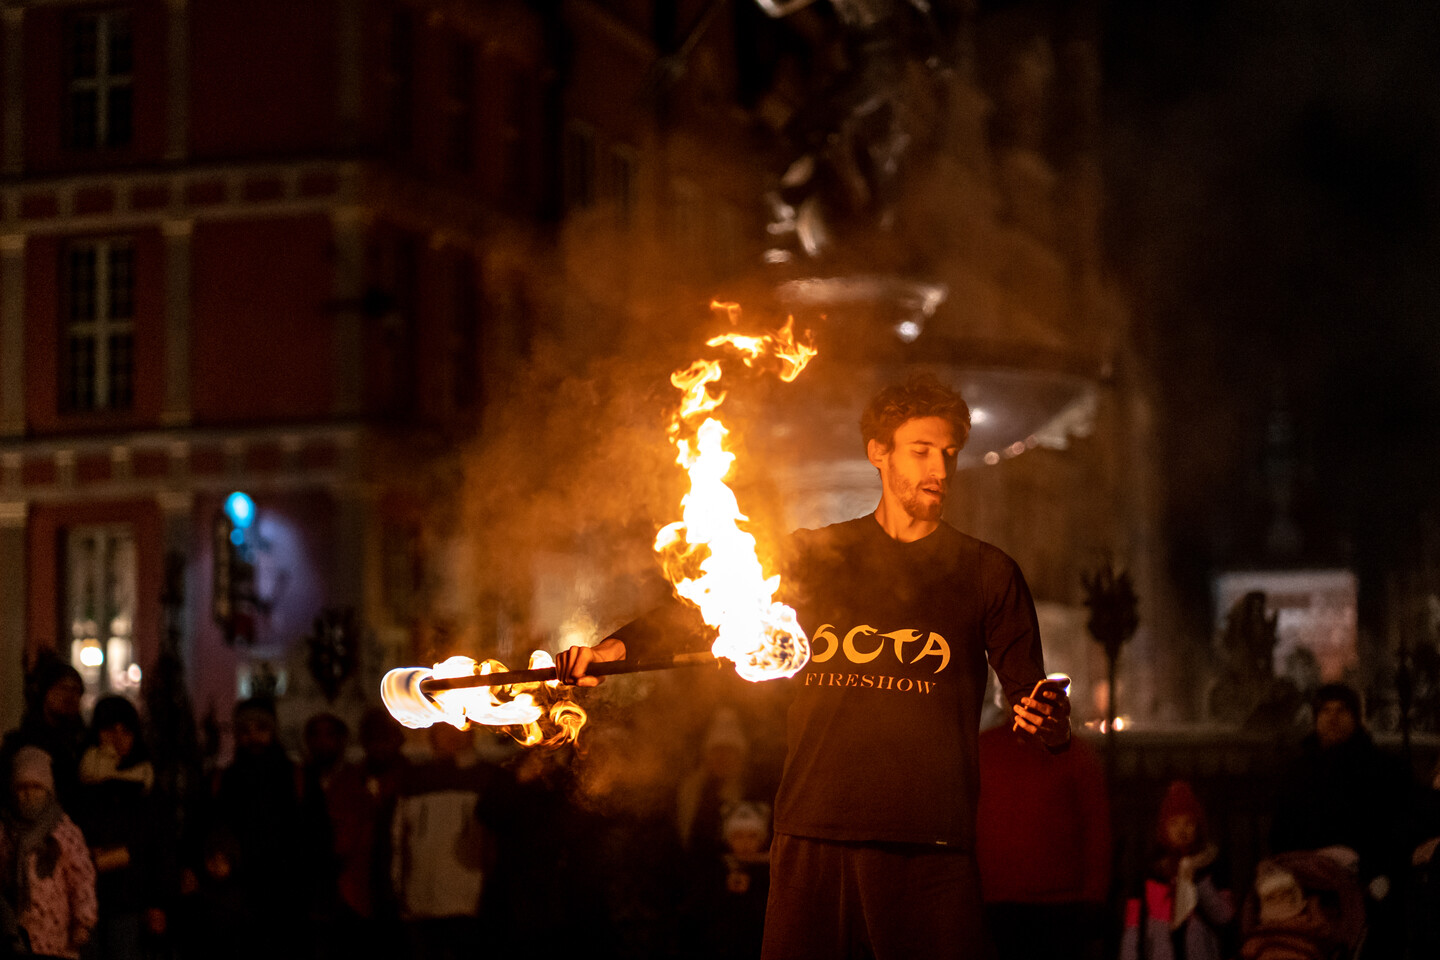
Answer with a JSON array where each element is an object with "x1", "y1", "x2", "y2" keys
[{"x1": 0, "y1": 661, "x2": 1440, "y2": 960}]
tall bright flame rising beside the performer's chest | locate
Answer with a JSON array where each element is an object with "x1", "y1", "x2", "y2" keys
[{"x1": 655, "y1": 304, "x2": 815, "y2": 681}]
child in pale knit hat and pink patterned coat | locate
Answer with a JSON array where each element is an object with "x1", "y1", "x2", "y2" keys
[{"x1": 0, "y1": 747, "x2": 96, "y2": 959}]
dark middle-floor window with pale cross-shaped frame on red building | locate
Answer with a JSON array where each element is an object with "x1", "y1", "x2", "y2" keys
[{"x1": 60, "y1": 239, "x2": 135, "y2": 413}]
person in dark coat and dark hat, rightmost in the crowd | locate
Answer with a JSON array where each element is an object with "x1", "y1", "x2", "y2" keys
[{"x1": 1270, "y1": 684, "x2": 1414, "y2": 957}]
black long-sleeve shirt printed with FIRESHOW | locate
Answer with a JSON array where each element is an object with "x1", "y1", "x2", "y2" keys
[{"x1": 616, "y1": 515, "x2": 1044, "y2": 851}]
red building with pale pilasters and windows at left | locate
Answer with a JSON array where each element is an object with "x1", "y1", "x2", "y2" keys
[{"x1": 0, "y1": 0, "x2": 550, "y2": 723}]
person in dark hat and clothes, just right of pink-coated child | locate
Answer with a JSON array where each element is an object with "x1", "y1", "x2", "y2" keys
[{"x1": 75, "y1": 697, "x2": 170, "y2": 960}]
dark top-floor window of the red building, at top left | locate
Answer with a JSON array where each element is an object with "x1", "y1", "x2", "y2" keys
[{"x1": 65, "y1": 10, "x2": 135, "y2": 150}]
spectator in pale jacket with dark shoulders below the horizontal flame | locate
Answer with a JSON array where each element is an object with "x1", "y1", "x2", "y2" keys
[{"x1": 390, "y1": 723, "x2": 500, "y2": 960}]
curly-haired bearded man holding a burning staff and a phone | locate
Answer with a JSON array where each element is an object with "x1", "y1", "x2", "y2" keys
[{"x1": 556, "y1": 376, "x2": 1070, "y2": 960}]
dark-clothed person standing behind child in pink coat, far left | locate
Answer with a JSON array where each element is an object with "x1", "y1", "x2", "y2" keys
[{"x1": 0, "y1": 652, "x2": 85, "y2": 813}]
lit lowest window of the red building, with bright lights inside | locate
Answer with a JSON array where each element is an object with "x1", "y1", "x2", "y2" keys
[{"x1": 65, "y1": 524, "x2": 141, "y2": 698}]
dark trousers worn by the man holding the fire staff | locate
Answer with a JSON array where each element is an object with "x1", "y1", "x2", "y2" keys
[{"x1": 760, "y1": 833, "x2": 992, "y2": 960}]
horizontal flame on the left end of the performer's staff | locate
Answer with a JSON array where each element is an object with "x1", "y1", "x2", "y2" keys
[{"x1": 380, "y1": 651, "x2": 586, "y2": 747}]
